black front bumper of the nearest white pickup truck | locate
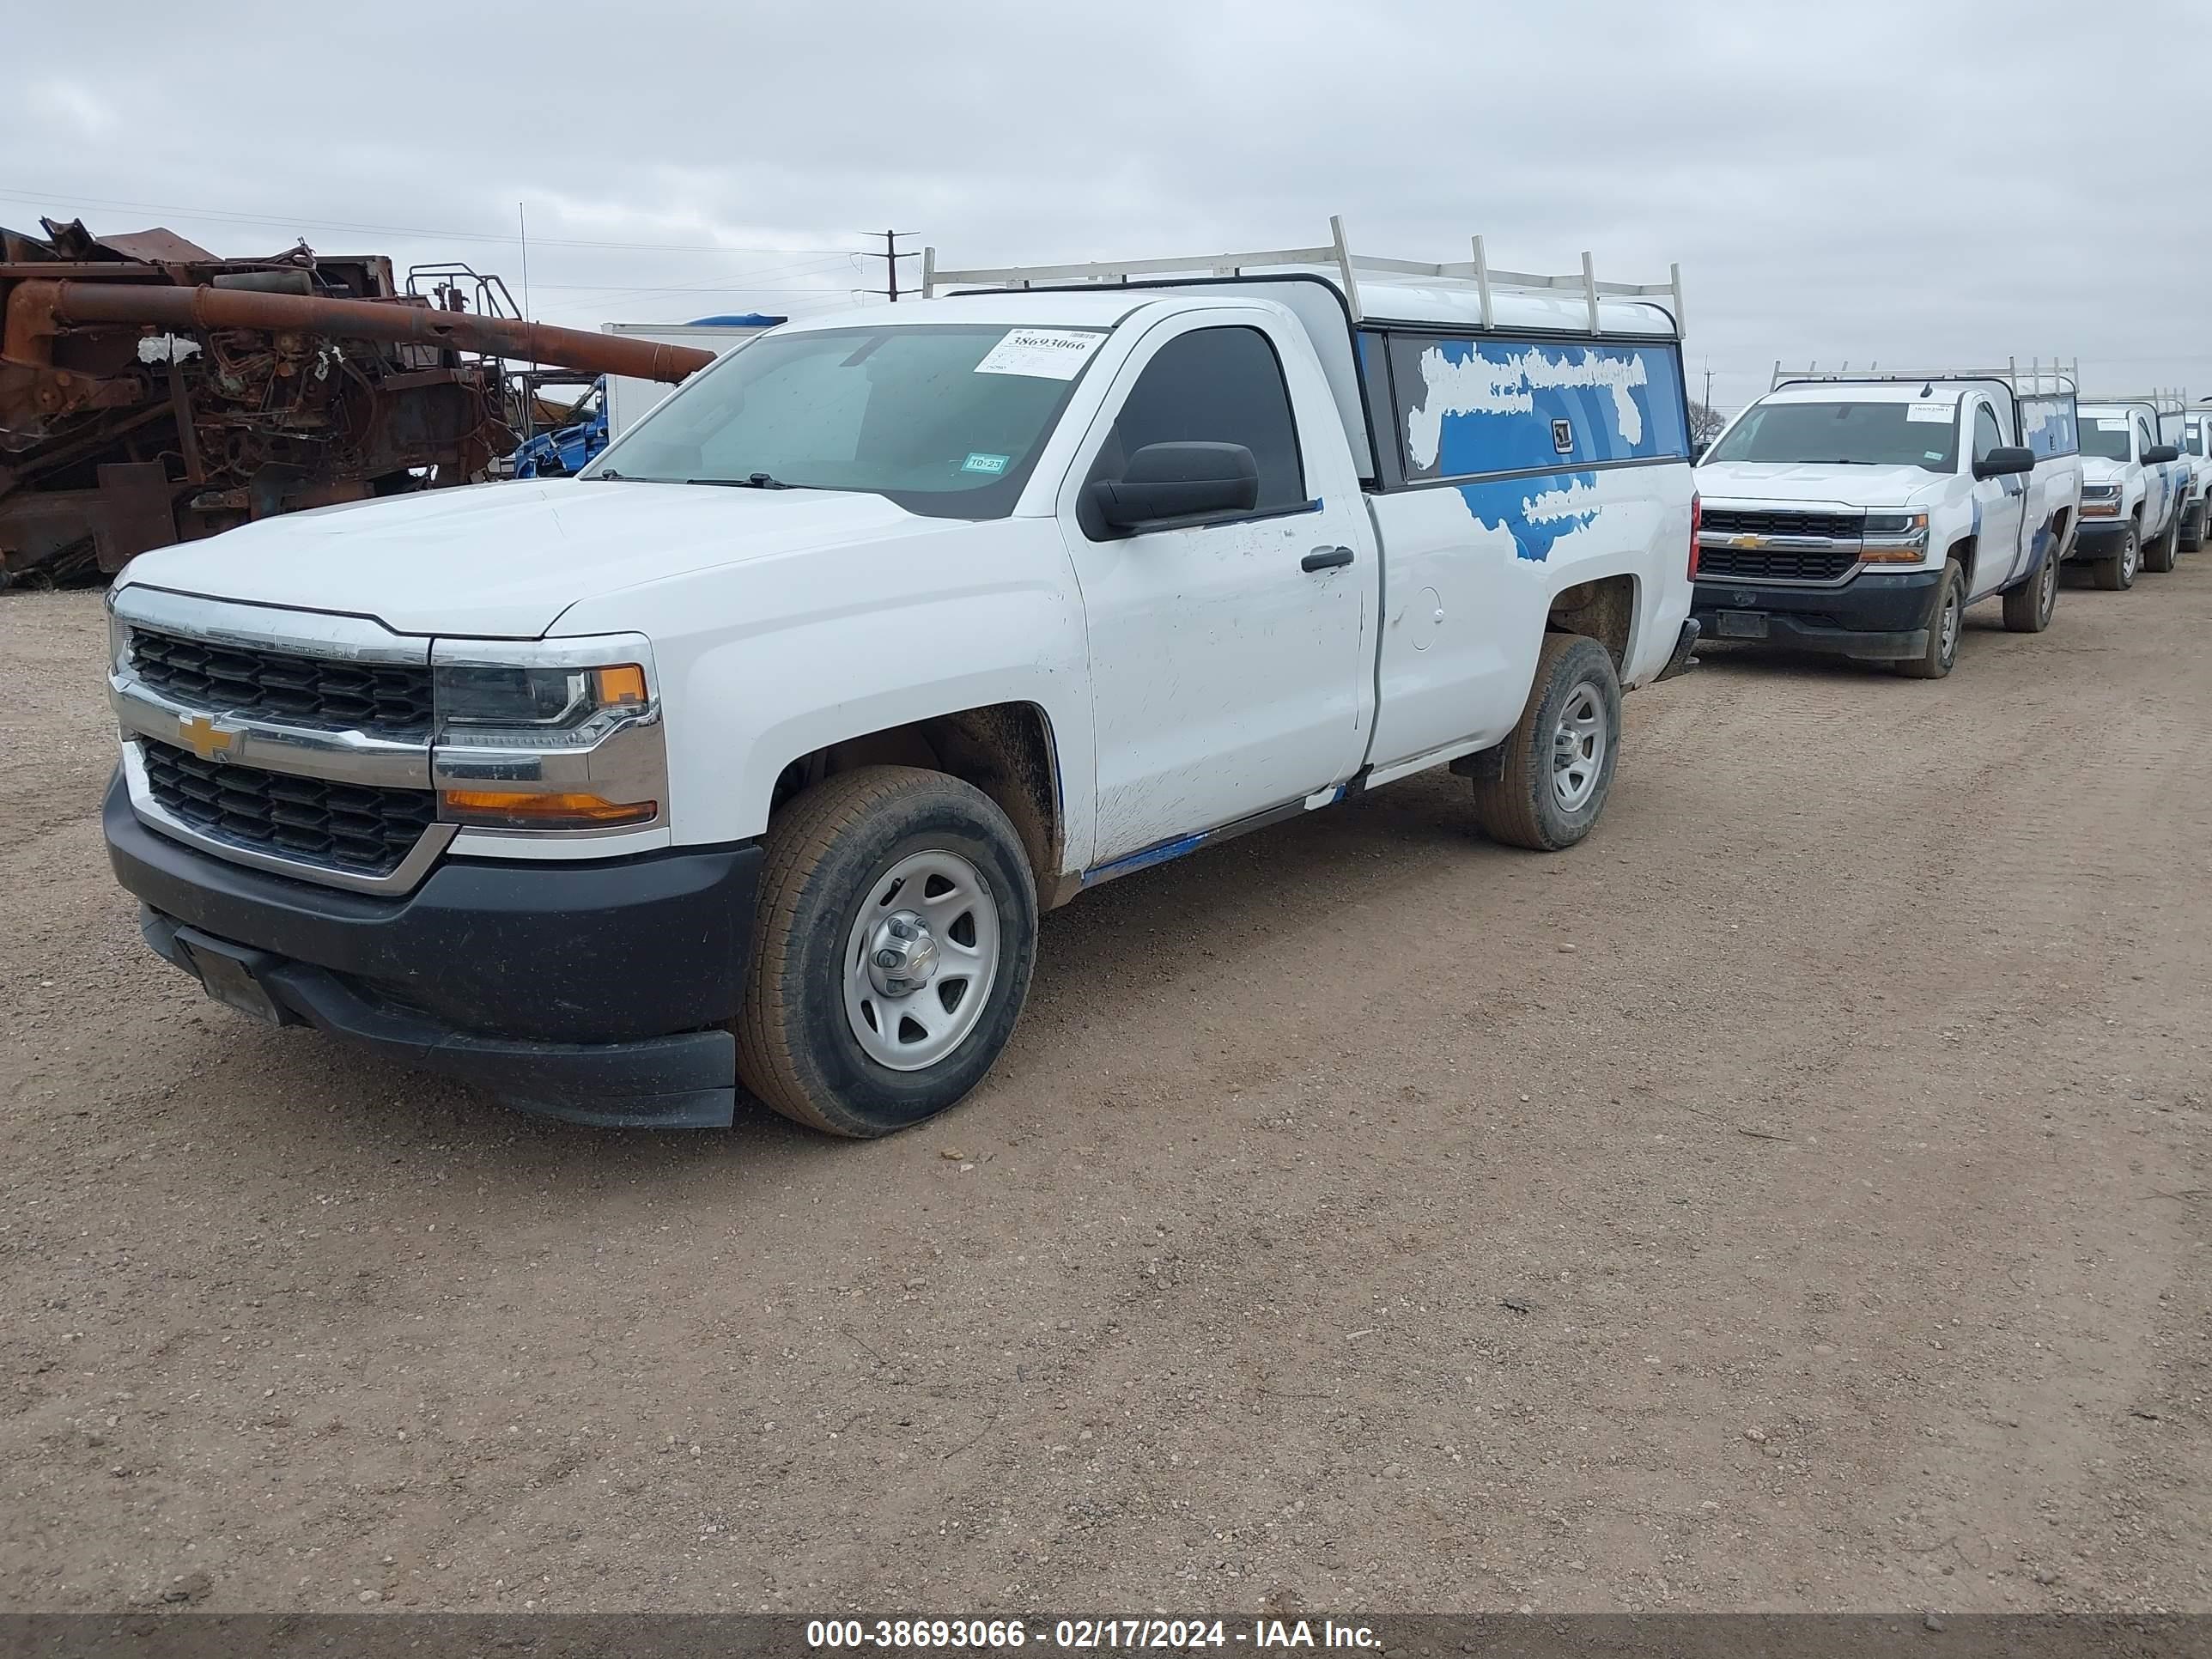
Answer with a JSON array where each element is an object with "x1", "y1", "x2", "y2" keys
[{"x1": 101, "y1": 776, "x2": 761, "y2": 1128}]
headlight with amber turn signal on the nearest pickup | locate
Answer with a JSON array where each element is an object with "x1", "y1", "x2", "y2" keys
[{"x1": 431, "y1": 635, "x2": 668, "y2": 832}]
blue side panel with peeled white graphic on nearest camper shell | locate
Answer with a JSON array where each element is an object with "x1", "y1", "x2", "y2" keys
[{"x1": 1391, "y1": 334, "x2": 1690, "y2": 483}]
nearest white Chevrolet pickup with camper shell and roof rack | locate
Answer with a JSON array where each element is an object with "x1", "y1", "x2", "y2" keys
[{"x1": 104, "y1": 232, "x2": 1697, "y2": 1134}]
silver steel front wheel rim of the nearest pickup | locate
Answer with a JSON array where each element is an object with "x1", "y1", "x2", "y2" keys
[{"x1": 842, "y1": 849, "x2": 1000, "y2": 1071}]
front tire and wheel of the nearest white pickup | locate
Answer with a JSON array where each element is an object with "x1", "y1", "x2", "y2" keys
[{"x1": 734, "y1": 765, "x2": 1037, "y2": 1137}]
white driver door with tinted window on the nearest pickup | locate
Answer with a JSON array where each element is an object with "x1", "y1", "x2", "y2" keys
[{"x1": 1060, "y1": 310, "x2": 1380, "y2": 872}]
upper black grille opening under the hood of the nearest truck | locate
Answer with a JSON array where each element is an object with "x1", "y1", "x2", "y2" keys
[{"x1": 131, "y1": 629, "x2": 431, "y2": 738}]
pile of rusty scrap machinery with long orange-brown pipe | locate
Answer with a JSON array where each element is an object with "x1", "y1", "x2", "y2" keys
[{"x1": 0, "y1": 219, "x2": 712, "y2": 586}]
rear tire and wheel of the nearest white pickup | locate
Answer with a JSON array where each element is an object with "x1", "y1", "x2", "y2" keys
[{"x1": 1475, "y1": 633, "x2": 1621, "y2": 852}]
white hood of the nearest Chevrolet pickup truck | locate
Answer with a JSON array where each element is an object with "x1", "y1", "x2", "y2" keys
[{"x1": 124, "y1": 477, "x2": 963, "y2": 639}]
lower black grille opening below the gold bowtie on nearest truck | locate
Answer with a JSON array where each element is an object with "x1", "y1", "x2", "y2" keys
[{"x1": 143, "y1": 741, "x2": 438, "y2": 876}]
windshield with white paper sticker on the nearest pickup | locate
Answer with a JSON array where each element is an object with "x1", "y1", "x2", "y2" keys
[{"x1": 584, "y1": 323, "x2": 1106, "y2": 518}]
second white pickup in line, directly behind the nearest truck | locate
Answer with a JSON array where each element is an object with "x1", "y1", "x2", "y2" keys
[{"x1": 1697, "y1": 365, "x2": 2081, "y2": 679}]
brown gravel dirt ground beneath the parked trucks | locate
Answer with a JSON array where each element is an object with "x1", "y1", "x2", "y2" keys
[{"x1": 0, "y1": 570, "x2": 2212, "y2": 1614}]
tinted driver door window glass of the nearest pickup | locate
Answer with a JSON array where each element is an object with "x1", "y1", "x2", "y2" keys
[{"x1": 1093, "y1": 327, "x2": 1307, "y2": 514}]
